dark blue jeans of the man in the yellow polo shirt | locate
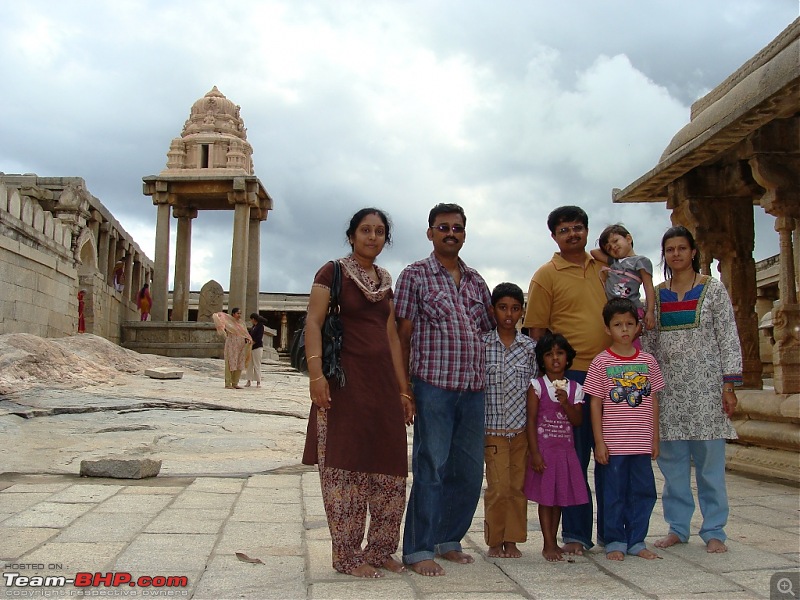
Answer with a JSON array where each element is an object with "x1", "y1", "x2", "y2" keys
[{"x1": 561, "y1": 371, "x2": 603, "y2": 549}]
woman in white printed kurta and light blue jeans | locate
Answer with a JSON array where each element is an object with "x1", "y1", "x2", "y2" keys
[{"x1": 643, "y1": 226, "x2": 742, "y2": 552}]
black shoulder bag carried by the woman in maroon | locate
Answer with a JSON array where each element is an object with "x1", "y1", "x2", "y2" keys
[{"x1": 289, "y1": 260, "x2": 345, "y2": 387}]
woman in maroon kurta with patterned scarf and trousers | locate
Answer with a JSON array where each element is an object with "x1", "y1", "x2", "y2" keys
[{"x1": 303, "y1": 208, "x2": 414, "y2": 577}]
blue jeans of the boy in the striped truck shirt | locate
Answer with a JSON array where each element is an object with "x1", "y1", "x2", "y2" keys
[{"x1": 595, "y1": 454, "x2": 657, "y2": 554}]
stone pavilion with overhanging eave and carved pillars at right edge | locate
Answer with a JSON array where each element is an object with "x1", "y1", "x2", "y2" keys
[{"x1": 612, "y1": 19, "x2": 800, "y2": 481}]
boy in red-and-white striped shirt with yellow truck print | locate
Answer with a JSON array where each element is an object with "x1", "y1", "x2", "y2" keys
[{"x1": 583, "y1": 298, "x2": 664, "y2": 560}]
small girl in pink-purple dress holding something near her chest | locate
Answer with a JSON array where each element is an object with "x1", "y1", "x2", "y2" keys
[{"x1": 524, "y1": 333, "x2": 589, "y2": 562}]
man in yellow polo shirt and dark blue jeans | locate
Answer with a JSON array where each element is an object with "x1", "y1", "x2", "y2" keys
[{"x1": 522, "y1": 206, "x2": 611, "y2": 554}]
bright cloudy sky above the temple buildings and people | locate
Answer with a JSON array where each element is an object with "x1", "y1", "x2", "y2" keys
[{"x1": 0, "y1": 0, "x2": 798, "y2": 292}]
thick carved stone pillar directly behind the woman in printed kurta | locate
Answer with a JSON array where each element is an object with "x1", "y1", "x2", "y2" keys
[{"x1": 669, "y1": 164, "x2": 762, "y2": 389}]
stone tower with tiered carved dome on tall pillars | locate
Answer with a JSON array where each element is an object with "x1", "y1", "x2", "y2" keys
[{"x1": 143, "y1": 86, "x2": 272, "y2": 321}]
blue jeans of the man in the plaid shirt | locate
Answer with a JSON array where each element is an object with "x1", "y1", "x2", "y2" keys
[{"x1": 403, "y1": 377, "x2": 484, "y2": 564}]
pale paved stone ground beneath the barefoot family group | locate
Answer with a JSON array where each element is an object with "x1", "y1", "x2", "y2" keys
[{"x1": 0, "y1": 361, "x2": 800, "y2": 600}]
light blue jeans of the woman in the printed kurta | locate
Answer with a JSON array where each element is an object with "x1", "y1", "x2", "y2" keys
[{"x1": 658, "y1": 440, "x2": 728, "y2": 544}]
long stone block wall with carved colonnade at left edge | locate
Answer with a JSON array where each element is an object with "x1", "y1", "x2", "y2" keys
[{"x1": 0, "y1": 173, "x2": 152, "y2": 343}]
